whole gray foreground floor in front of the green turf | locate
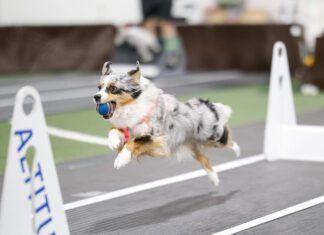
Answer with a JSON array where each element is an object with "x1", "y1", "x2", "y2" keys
[{"x1": 52, "y1": 110, "x2": 324, "y2": 234}]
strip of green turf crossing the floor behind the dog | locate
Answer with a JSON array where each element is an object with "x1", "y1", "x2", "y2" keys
[{"x1": 0, "y1": 85, "x2": 324, "y2": 172}]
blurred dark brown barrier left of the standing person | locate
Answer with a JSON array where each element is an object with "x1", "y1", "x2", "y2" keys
[{"x1": 0, "y1": 25, "x2": 116, "y2": 72}]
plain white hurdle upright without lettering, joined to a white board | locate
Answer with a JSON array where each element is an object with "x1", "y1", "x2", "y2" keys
[{"x1": 264, "y1": 42, "x2": 324, "y2": 161}]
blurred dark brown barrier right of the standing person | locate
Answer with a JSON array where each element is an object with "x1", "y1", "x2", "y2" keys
[{"x1": 178, "y1": 24, "x2": 303, "y2": 71}]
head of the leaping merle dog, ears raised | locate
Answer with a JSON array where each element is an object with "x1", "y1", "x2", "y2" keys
[{"x1": 93, "y1": 61, "x2": 142, "y2": 108}]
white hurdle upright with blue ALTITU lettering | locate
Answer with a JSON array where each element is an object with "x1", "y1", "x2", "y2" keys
[{"x1": 0, "y1": 87, "x2": 69, "y2": 235}]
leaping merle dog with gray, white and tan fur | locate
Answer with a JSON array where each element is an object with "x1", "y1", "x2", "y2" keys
[{"x1": 93, "y1": 62, "x2": 240, "y2": 186}]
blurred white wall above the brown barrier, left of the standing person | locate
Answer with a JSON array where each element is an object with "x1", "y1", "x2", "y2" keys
[{"x1": 0, "y1": 0, "x2": 142, "y2": 26}]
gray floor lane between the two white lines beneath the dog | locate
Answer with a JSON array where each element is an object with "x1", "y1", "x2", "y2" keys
[{"x1": 67, "y1": 161, "x2": 324, "y2": 234}]
